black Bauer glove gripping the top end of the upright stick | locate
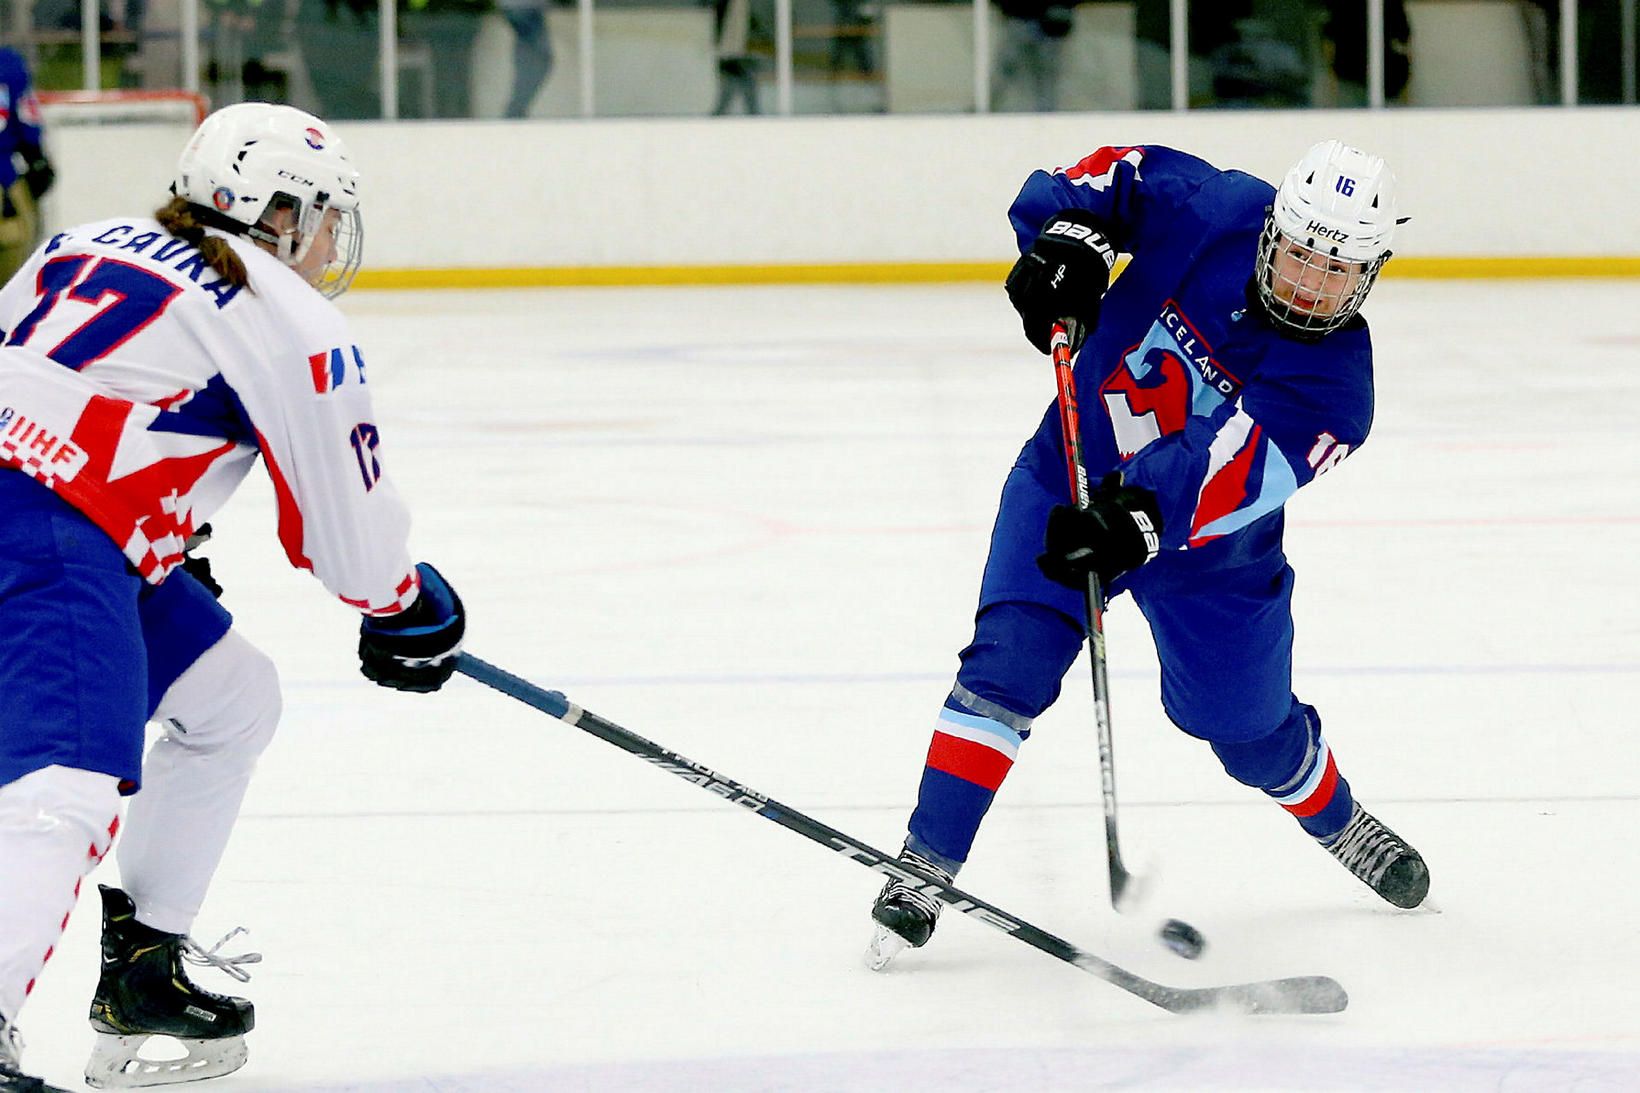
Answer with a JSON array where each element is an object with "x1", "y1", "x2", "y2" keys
[{"x1": 1004, "y1": 208, "x2": 1117, "y2": 353}]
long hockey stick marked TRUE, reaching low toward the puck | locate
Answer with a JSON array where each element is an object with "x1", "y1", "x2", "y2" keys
[{"x1": 456, "y1": 653, "x2": 1350, "y2": 1014}]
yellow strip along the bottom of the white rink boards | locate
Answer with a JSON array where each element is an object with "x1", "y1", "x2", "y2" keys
[{"x1": 356, "y1": 254, "x2": 1640, "y2": 289}]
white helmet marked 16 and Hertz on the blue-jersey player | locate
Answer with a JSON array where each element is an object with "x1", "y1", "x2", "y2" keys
[{"x1": 1255, "y1": 141, "x2": 1401, "y2": 336}]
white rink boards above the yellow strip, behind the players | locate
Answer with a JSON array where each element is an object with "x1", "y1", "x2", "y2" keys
[{"x1": 38, "y1": 108, "x2": 1640, "y2": 269}]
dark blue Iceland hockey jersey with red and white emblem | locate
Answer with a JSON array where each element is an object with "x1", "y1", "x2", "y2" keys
[{"x1": 1009, "y1": 146, "x2": 1373, "y2": 571}]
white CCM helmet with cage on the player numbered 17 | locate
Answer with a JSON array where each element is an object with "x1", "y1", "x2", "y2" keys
[{"x1": 171, "y1": 102, "x2": 364, "y2": 297}]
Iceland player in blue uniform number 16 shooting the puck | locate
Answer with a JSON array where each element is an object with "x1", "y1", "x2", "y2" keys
[{"x1": 868, "y1": 141, "x2": 1428, "y2": 968}]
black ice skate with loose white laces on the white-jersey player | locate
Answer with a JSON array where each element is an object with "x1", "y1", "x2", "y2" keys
[{"x1": 85, "y1": 885, "x2": 259, "y2": 1090}]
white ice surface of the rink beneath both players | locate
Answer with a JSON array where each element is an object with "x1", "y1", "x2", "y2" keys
[{"x1": 12, "y1": 279, "x2": 1640, "y2": 1093}]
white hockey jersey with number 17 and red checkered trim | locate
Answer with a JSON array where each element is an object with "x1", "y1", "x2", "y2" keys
[{"x1": 0, "y1": 217, "x2": 420, "y2": 615}]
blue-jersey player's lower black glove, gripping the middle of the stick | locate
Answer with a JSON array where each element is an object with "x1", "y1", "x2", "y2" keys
[{"x1": 1036, "y1": 474, "x2": 1161, "y2": 589}]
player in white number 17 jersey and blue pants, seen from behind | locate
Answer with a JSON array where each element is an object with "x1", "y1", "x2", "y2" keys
[{"x1": 0, "y1": 103, "x2": 464, "y2": 1091}]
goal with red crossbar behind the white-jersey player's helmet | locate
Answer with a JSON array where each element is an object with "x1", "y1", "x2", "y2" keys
[{"x1": 39, "y1": 90, "x2": 210, "y2": 233}]
